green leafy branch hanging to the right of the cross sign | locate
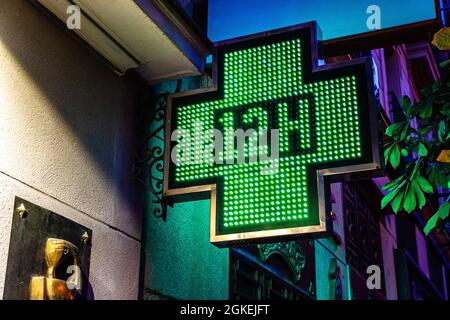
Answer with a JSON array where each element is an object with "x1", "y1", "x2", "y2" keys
[{"x1": 382, "y1": 44, "x2": 450, "y2": 234}]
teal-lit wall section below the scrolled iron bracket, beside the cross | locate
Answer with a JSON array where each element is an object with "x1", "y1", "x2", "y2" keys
[{"x1": 145, "y1": 200, "x2": 229, "y2": 300}]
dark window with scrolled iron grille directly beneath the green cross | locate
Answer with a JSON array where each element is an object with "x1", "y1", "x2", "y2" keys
[{"x1": 229, "y1": 244, "x2": 316, "y2": 300}]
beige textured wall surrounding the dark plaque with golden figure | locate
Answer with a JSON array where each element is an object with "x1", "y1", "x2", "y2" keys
[{"x1": 0, "y1": 0, "x2": 141, "y2": 299}]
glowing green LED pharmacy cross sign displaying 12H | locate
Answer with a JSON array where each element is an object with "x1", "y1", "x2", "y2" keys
[{"x1": 165, "y1": 24, "x2": 379, "y2": 246}]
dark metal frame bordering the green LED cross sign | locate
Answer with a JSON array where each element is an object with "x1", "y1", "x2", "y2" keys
[{"x1": 163, "y1": 23, "x2": 381, "y2": 247}]
